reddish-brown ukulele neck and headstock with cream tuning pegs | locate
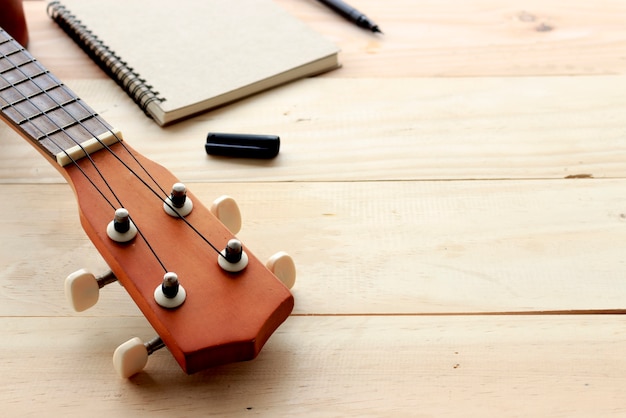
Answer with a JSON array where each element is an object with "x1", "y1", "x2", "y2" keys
[{"x1": 0, "y1": 29, "x2": 295, "y2": 377}]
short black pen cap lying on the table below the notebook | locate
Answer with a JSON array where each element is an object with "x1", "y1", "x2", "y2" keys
[{"x1": 204, "y1": 132, "x2": 280, "y2": 158}]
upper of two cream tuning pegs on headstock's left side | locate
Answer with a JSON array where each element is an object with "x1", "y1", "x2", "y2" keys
[{"x1": 65, "y1": 269, "x2": 117, "y2": 312}]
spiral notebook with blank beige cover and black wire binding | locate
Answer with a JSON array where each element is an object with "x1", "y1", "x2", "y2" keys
[{"x1": 48, "y1": 0, "x2": 339, "y2": 125}]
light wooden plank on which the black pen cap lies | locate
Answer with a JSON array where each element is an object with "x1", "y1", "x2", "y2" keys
[{"x1": 0, "y1": 76, "x2": 626, "y2": 182}]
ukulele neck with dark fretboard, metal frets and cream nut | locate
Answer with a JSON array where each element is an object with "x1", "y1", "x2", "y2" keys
[{"x1": 0, "y1": 29, "x2": 121, "y2": 166}]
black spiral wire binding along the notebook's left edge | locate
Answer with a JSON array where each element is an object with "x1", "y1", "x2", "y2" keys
[{"x1": 47, "y1": 1, "x2": 165, "y2": 117}]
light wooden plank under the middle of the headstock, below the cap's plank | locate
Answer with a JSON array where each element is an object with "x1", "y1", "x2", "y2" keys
[{"x1": 0, "y1": 179, "x2": 626, "y2": 315}]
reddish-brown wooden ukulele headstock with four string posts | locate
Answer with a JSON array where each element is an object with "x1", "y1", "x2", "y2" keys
[{"x1": 65, "y1": 140, "x2": 295, "y2": 374}]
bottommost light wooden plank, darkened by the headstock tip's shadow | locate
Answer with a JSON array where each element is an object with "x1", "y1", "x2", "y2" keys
[{"x1": 0, "y1": 316, "x2": 626, "y2": 417}]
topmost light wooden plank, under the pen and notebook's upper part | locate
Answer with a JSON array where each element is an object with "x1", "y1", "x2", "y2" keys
[{"x1": 25, "y1": 0, "x2": 626, "y2": 78}]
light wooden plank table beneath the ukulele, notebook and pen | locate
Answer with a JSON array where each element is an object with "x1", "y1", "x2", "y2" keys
[{"x1": 0, "y1": 0, "x2": 626, "y2": 417}]
